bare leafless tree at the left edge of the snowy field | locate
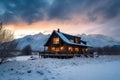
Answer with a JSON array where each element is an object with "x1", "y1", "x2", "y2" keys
[{"x1": 0, "y1": 23, "x2": 16, "y2": 64}]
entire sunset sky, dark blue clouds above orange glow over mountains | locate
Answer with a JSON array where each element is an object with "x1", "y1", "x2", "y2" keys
[{"x1": 0, "y1": 0, "x2": 120, "y2": 40}]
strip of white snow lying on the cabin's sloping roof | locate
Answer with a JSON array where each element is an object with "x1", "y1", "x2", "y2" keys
[{"x1": 55, "y1": 31, "x2": 88, "y2": 47}]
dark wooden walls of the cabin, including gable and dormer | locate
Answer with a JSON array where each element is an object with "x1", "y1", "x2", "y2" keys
[{"x1": 45, "y1": 31, "x2": 87, "y2": 54}]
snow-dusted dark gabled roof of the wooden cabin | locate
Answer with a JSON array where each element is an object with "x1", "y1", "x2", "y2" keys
[{"x1": 45, "y1": 30, "x2": 88, "y2": 47}]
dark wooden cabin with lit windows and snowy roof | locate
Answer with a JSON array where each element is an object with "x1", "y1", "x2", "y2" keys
[{"x1": 44, "y1": 29, "x2": 88, "y2": 56}]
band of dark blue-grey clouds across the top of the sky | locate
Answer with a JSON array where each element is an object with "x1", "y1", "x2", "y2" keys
[{"x1": 0, "y1": 0, "x2": 120, "y2": 24}]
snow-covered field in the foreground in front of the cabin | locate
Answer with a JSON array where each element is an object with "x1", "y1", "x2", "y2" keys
[{"x1": 0, "y1": 56, "x2": 120, "y2": 80}]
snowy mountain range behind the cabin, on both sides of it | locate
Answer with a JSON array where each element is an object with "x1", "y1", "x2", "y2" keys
[{"x1": 16, "y1": 33, "x2": 120, "y2": 51}]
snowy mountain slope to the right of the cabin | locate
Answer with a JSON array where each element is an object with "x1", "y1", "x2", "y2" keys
[{"x1": 78, "y1": 34, "x2": 120, "y2": 47}]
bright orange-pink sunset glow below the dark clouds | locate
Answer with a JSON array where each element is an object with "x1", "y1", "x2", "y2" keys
[{"x1": 5, "y1": 17, "x2": 98, "y2": 38}]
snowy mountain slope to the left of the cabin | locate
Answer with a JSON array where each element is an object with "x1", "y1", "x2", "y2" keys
[{"x1": 16, "y1": 33, "x2": 50, "y2": 51}]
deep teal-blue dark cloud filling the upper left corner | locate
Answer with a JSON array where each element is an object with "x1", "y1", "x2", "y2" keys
[{"x1": 0, "y1": 0, "x2": 48, "y2": 23}]
